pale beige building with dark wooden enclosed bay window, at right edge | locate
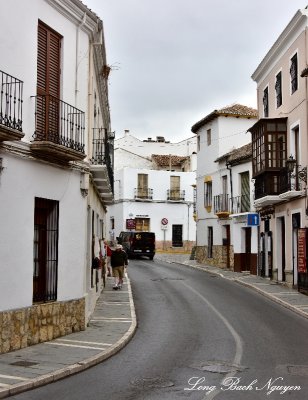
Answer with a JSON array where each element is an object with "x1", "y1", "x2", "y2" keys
[{"x1": 250, "y1": 5, "x2": 308, "y2": 290}]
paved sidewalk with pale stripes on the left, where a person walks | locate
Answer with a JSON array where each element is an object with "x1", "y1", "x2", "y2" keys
[{"x1": 0, "y1": 277, "x2": 137, "y2": 399}]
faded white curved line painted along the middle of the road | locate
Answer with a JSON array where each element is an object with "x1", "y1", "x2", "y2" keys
[{"x1": 182, "y1": 282, "x2": 243, "y2": 400}]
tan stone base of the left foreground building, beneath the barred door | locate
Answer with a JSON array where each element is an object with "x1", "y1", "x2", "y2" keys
[{"x1": 0, "y1": 298, "x2": 85, "y2": 354}]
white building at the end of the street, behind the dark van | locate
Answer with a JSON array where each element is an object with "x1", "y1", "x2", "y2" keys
[{"x1": 108, "y1": 131, "x2": 196, "y2": 251}]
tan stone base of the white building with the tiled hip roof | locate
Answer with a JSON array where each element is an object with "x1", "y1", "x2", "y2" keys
[{"x1": 195, "y1": 246, "x2": 234, "y2": 270}]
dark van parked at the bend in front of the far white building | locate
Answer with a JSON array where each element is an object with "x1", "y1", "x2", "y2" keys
[{"x1": 117, "y1": 231, "x2": 155, "y2": 260}]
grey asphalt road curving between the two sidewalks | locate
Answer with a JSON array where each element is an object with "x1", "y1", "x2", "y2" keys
[{"x1": 11, "y1": 259, "x2": 308, "y2": 400}]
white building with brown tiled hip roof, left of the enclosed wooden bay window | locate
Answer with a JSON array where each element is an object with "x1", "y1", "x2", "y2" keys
[{"x1": 192, "y1": 104, "x2": 258, "y2": 273}]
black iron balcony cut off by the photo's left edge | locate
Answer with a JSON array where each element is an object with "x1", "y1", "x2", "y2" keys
[{"x1": 0, "y1": 71, "x2": 24, "y2": 142}]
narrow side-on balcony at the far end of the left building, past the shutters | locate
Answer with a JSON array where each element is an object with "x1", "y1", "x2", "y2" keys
[{"x1": 90, "y1": 128, "x2": 114, "y2": 204}]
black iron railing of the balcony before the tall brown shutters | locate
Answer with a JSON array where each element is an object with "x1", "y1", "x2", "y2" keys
[{"x1": 33, "y1": 95, "x2": 85, "y2": 154}]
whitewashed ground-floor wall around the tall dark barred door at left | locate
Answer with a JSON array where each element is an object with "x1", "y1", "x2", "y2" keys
[{"x1": 0, "y1": 154, "x2": 86, "y2": 311}]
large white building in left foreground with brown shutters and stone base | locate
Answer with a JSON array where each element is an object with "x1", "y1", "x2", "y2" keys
[{"x1": 0, "y1": 0, "x2": 113, "y2": 353}]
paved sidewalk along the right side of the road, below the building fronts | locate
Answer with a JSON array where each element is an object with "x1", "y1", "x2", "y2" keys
[{"x1": 156, "y1": 254, "x2": 308, "y2": 318}]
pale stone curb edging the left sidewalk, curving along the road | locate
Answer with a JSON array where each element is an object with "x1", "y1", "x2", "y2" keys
[{"x1": 0, "y1": 277, "x2": 137, "y2": 399}]
